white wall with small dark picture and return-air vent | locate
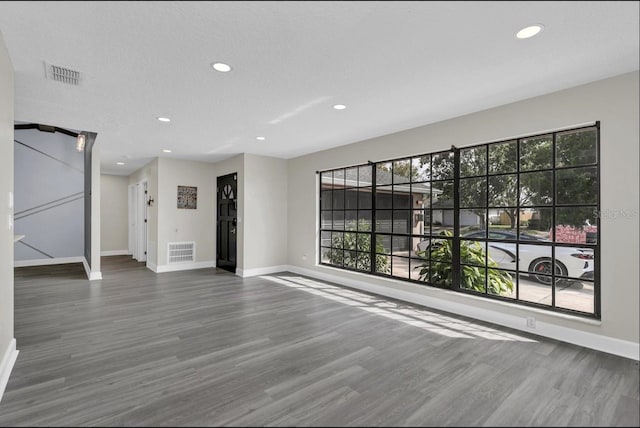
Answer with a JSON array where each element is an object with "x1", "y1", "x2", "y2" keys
[{"x1": 155, "y1": 158, "x2": 216, "y2": 270}]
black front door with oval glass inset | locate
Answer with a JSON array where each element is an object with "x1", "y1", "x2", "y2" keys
[{"x1": 216, "y1": 173, "x2": 238, "y2": 273}]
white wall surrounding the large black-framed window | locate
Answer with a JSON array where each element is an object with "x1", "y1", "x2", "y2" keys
[{"x1": 288, "y1": 72, "x2": 640, "y2": 352}]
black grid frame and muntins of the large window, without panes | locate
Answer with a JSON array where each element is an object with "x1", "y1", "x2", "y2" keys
[{"x1": 318, "y1": 121, "x2": 602, "y2": 319}]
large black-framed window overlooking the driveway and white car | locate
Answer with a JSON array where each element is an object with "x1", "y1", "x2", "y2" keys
[{"x1": 319, "y1": 123, "x2": 600, "y2": 318}]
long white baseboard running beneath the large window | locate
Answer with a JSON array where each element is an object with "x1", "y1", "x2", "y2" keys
[{"x1": 286, "y1": 265, "x2": 640, "y2": 361}]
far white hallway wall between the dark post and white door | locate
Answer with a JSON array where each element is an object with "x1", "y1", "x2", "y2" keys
[{"x1": 100, "y1": 174, "x2": 129, "y2": 253}]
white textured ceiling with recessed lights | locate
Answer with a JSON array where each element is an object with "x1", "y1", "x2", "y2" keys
[{"x1": 0, "y1": 1, "x2": 639, "y2": 174}]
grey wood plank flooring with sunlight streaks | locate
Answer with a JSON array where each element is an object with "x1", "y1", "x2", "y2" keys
[{"x1": 0, "y1": 256, "x2": 640, "y2": 426}]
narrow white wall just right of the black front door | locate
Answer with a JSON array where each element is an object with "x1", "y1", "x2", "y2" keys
[{"x1": 243, "y1": 154, "x2": 288, "y2": 275}]
